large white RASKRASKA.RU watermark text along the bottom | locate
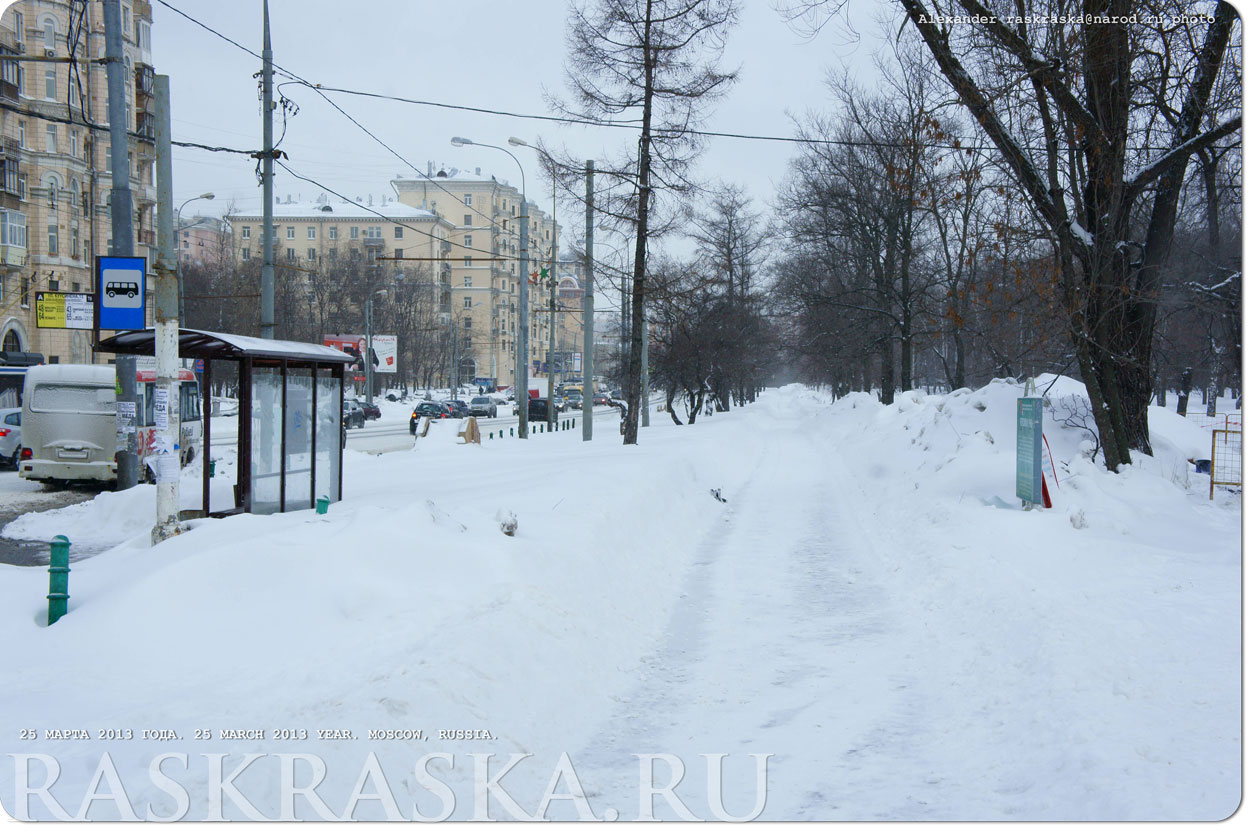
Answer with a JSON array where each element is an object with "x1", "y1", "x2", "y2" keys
[{"x1": 0, "y1": 751, "x2": 773, "y2": 822}]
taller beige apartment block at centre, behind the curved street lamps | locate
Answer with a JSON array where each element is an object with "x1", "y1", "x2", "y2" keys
[{"x1": 391, "y1": 165, "x2": 581, "y2": 386}]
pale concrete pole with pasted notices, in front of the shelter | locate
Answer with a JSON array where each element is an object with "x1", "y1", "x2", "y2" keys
[{"x1": 151, "y1": 75, "x2": 181, "y2": 543}]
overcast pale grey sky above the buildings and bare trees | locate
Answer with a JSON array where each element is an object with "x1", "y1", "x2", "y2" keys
[{"x1": 153, "y1": 0, "x2": 893, "y2": 251}]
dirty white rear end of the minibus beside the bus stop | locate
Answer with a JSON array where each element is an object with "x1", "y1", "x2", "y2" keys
[{"x1": 18, "y1": 364, "x2": 118, "y2": 481}]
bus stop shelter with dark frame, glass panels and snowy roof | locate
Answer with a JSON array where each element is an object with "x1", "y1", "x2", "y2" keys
[{"x1": 96, "y1": 329, "x2": 354, "y2": 517}]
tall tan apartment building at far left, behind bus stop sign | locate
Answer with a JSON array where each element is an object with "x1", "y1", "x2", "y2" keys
[{"x1": 0, "y1": 0, "x2": 156, "y2": 362}]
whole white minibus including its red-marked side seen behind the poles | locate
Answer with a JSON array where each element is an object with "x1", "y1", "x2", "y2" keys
[{"x1": 18, "y1": 364, "x2": 204, "y2": 482}]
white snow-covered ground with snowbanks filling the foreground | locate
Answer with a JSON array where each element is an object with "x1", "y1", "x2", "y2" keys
[{"x1": 0, "y1": 379, "x2": 1241, "y2": 820}]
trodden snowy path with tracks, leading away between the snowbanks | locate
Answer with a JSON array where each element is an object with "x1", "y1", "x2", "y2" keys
[{"x1": 545, "y1": 399, "x2": 919, "y2": 820}]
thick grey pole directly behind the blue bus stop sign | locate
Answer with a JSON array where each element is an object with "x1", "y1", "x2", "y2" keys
[{"x1": 104, "y1": 0, "x2": 139, "y2": 490}]
